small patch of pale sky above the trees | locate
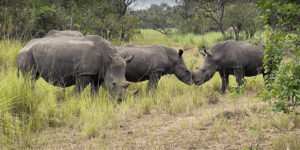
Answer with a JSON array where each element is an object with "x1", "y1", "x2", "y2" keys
[{"x1": 129, "y1": 0, "x2": 176, "y2": 9}]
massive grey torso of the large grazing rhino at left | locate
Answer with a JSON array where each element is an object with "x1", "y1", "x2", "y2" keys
[{"x1": 21, "y1": 36, "x2": 107, "y2": 86}]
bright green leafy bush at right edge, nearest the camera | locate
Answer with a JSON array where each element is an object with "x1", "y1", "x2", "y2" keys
[{"x1": 258, "y1": 0, "x2": 300, "y2": 113}]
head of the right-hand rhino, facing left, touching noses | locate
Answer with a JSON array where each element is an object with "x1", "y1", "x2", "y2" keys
[{"x1": 192, "y1": 49, "x2": 217, "y2": 85}]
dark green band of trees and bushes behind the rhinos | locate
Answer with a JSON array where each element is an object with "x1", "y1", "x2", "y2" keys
[{"x1": 0, "y1": 0, "x2": 282, "y2": 41}]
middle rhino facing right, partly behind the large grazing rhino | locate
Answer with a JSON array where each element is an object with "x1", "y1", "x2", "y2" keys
[{"x1": 117, "y1": 45, "x2": 192, "y2": 92}]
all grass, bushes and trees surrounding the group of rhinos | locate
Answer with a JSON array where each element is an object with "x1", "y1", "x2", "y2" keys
[{"x1": 0, "y1": 0, "x2": 300, "y2": 150}]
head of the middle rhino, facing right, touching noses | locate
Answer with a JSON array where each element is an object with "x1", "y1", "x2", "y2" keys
[{"x1": 173, "y1": 49, "x2": 193, "y2": 85}]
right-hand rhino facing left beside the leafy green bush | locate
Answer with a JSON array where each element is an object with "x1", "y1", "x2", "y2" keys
[{"x1": 193, "y1": 40, "x2": 270, "y2": 94}]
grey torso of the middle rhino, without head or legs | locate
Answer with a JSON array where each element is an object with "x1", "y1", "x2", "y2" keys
[{"x1": 117, "y1": 45, "x2": 176, "y2": 82}]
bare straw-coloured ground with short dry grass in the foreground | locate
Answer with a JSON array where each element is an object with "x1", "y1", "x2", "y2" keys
[{"x1": 32, "y1": 94, "x2": 300, "y2": 150}]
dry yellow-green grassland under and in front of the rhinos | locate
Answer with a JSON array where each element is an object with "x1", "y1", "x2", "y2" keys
[{"x1": 0, "y1": 31, "x2": 300, "y2": 150}]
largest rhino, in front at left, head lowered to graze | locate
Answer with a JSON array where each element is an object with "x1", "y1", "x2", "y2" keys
[{"x1": 17, "y1": 35, "x2": 137, "y2": 99}]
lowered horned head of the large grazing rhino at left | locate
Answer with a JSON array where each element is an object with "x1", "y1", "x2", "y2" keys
[{"x1": 103, "y1": 54, "x2": 139, "y2": 101}]
